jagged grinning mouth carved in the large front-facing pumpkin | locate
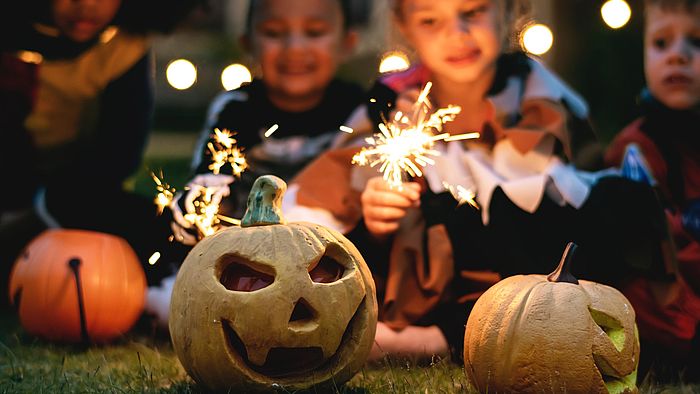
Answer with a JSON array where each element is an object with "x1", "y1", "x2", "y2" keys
[{"x1": 221, "y1": 298, "x2": 365, "y2": 378}]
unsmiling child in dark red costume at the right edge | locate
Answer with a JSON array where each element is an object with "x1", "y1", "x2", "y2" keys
[{"x1": 606, "y1": 0, "x2": 700, "y2": 379}]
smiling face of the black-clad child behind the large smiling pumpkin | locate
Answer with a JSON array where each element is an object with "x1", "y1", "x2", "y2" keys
[{"x1": 248, "y1": 0, "x2": 355, "y2": 105}]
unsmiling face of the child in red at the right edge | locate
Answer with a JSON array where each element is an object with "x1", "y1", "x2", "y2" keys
[{"x1": 644, "y1": 6, "x2": 700, "y2": 110}]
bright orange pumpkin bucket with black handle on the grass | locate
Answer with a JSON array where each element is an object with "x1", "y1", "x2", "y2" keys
[{"x1": 10, "y1": 229, "x2": 146, "y2": 343}]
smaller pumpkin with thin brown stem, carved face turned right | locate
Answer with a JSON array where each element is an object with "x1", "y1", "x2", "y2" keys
[{"x1": 464, "y1": 243, "x2": 639, "y2": 393}]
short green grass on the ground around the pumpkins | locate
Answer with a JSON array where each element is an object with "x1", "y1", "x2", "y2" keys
[{"x1": 0, "y1": 316, "x2": 474, "y2": 394}]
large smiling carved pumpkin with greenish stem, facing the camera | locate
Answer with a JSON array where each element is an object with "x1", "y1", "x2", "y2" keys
[{"x1": 169, "y1": 176, "x2": 377, "y2": 391}]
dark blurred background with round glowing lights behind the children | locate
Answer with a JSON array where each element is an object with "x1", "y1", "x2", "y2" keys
[{"x1": 134, "y1": 0, "x2": 644, "y2": 190}]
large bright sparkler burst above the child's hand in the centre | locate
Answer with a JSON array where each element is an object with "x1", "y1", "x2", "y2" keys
[{"x1": 352, "y1": 82, "x2": 479, "y2": 190}]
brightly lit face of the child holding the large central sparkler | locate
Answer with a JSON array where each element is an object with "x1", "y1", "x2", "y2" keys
[{"x1": 399, "y1": 0, "x2": 501, "y2": 82}]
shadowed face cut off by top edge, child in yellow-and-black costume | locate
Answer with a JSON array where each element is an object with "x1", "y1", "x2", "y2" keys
[{"x1": 52, "y1": 0, "x2": 121, "y2": 42}]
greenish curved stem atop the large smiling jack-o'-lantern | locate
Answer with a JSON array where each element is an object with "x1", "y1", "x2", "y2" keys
[{"x1": 241, "y1": 175, "x2": 287, "y2": 227}]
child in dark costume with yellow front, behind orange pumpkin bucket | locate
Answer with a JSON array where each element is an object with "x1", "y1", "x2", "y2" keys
[{"x1": 0, "y1": 0, "x2": 202, "y2": 310}]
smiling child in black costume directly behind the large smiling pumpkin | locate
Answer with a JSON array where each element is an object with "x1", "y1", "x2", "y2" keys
[{"x1": 167, "y1": 0, "x2": 365, "y2": 243}]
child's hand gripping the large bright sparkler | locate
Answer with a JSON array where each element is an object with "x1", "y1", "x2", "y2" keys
[{"x1": 361, "y1": 177, "x2": 421, "y2": 240}]
